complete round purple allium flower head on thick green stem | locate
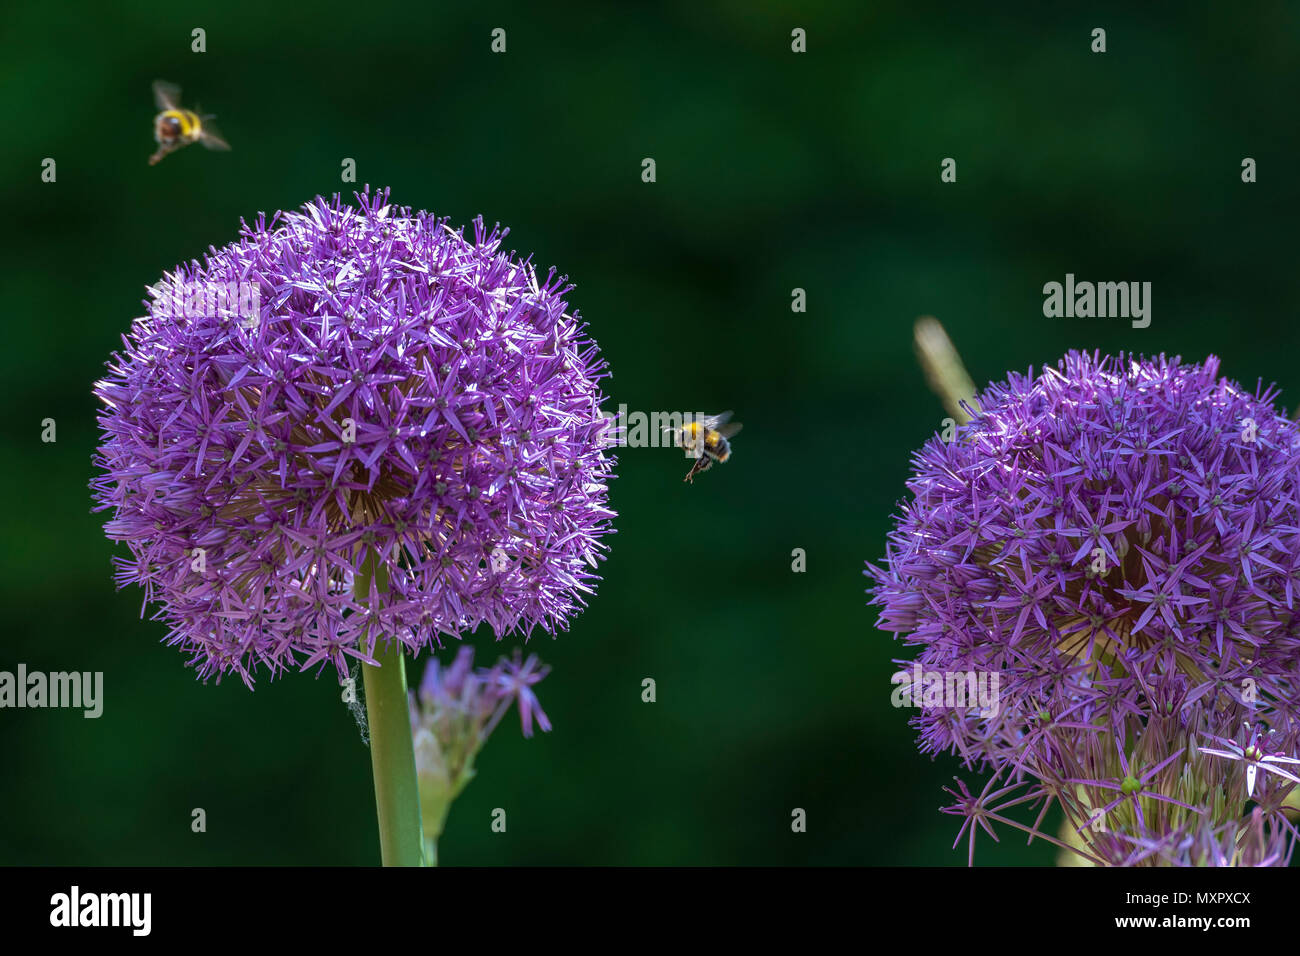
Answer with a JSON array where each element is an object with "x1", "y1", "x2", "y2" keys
[{"x1": 92, "y1": 189, "x2": 614, "y2": 685}]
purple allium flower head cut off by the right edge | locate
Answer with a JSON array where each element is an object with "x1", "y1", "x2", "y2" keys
[{"x1": 867, "y1": 352, "x2": 1300, "y2": 864}]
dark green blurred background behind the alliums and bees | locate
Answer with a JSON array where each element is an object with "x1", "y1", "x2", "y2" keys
[{"x1": 0, "y1": 0, "x2": 1300, "y2": 865}]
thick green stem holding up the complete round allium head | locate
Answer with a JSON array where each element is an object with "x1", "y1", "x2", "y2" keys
[{"x1": 352, "y1": 554, "x2": 424, "y2": 866}]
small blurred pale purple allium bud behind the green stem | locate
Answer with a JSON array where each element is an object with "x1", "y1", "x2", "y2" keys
[{"x1": 411, "y1": 646, "x2": 551, "y2": 860}]
